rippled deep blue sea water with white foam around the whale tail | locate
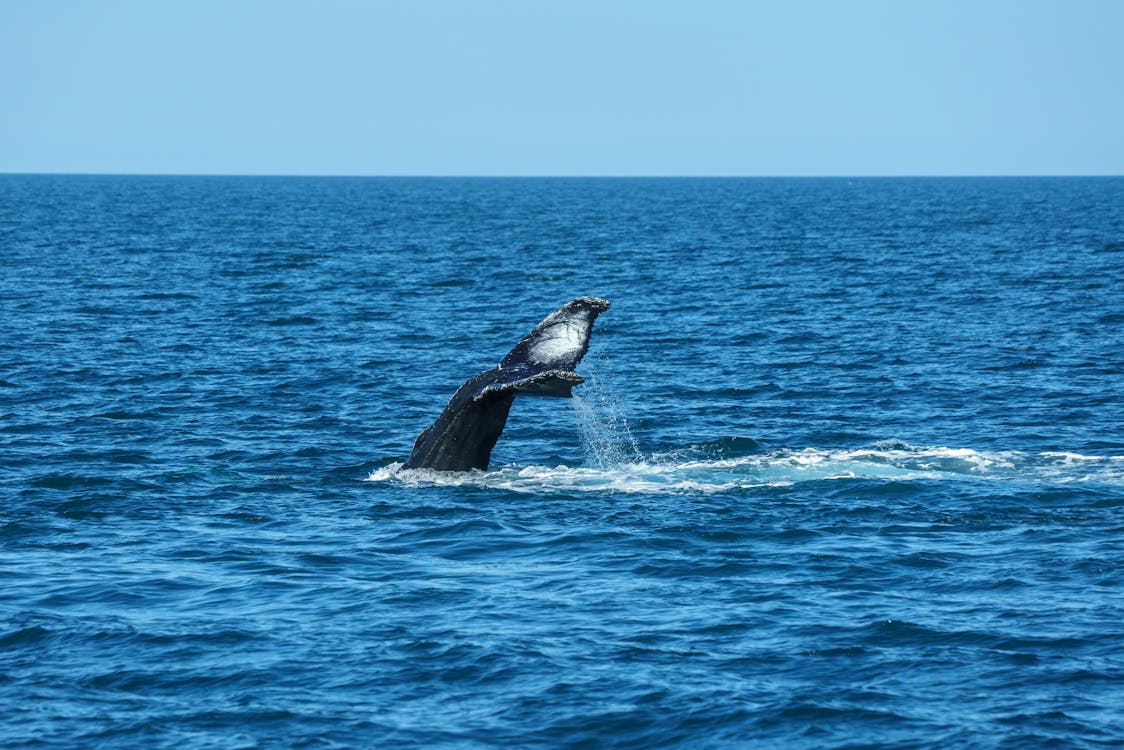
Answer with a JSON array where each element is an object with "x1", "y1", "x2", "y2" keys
[{"x1": 0, "y1": 175, "x2": 1124, "y2": 748}]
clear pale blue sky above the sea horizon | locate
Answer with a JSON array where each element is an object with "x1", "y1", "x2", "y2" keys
[{"x1": 0, "y1": 0, "x2": 1124, "y2": 175}]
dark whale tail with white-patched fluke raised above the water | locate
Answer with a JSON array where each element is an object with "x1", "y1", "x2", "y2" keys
[{"x1": 402, "y1": 297, "x2": 609, "y2": 471}]
